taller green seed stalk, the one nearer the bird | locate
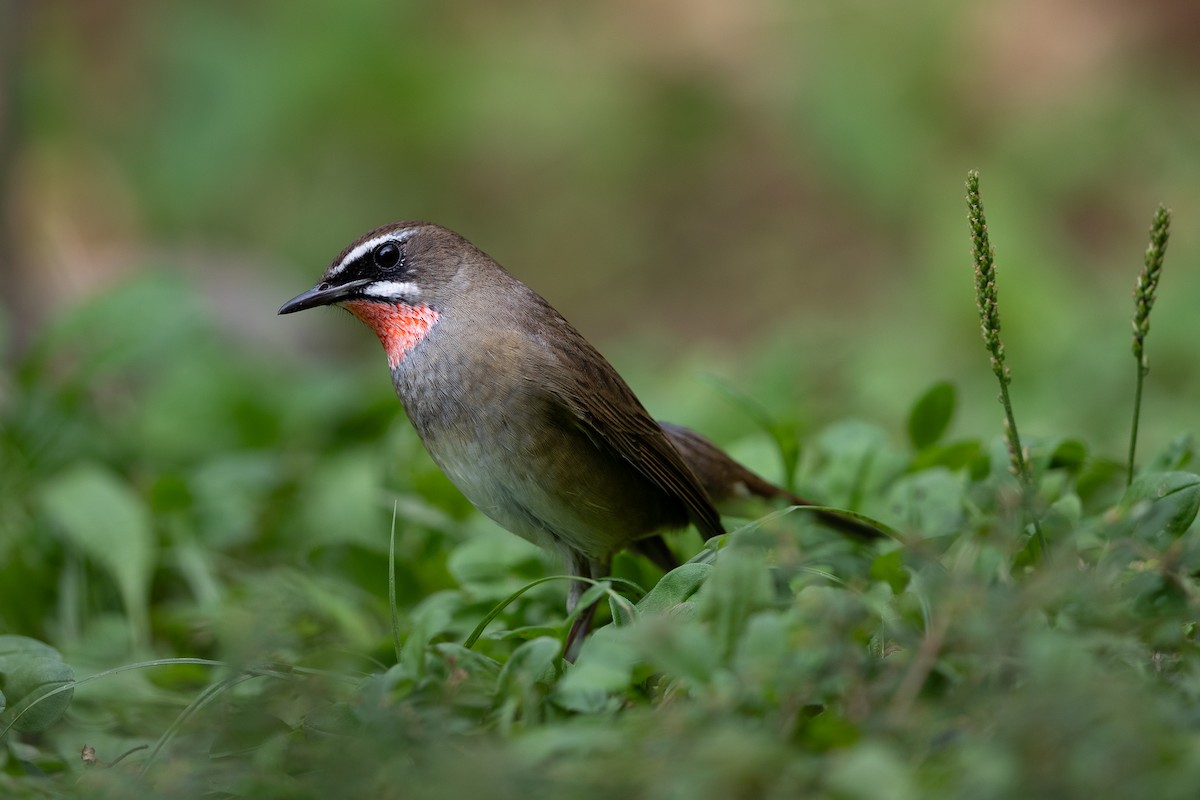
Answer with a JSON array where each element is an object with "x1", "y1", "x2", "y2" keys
[{"x1": 967, "y1": 169, "x2": 1046, "y2": 552}]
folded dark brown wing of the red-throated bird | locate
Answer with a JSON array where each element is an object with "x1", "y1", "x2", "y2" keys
[{"x1": 542, "y1": 328, "x2": 725, "y2": 539}]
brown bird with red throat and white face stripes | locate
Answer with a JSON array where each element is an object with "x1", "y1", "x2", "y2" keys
[{"x1": 278, "y1": 222, "x2": 878, "y2": 660}]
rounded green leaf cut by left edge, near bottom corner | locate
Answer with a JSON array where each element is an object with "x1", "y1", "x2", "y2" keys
[{"x1": 0, "y1": 636, "x2": 74, "y2": 733}]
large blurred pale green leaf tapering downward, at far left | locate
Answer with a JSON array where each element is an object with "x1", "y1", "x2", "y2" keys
[{"x1": 38, "y1": 464, "x2": 155, "y2": 643}]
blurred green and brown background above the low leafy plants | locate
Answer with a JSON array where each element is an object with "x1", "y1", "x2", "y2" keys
[{"x1": 0, "y1": 0, "x2": 1200, "y2": 447}]
